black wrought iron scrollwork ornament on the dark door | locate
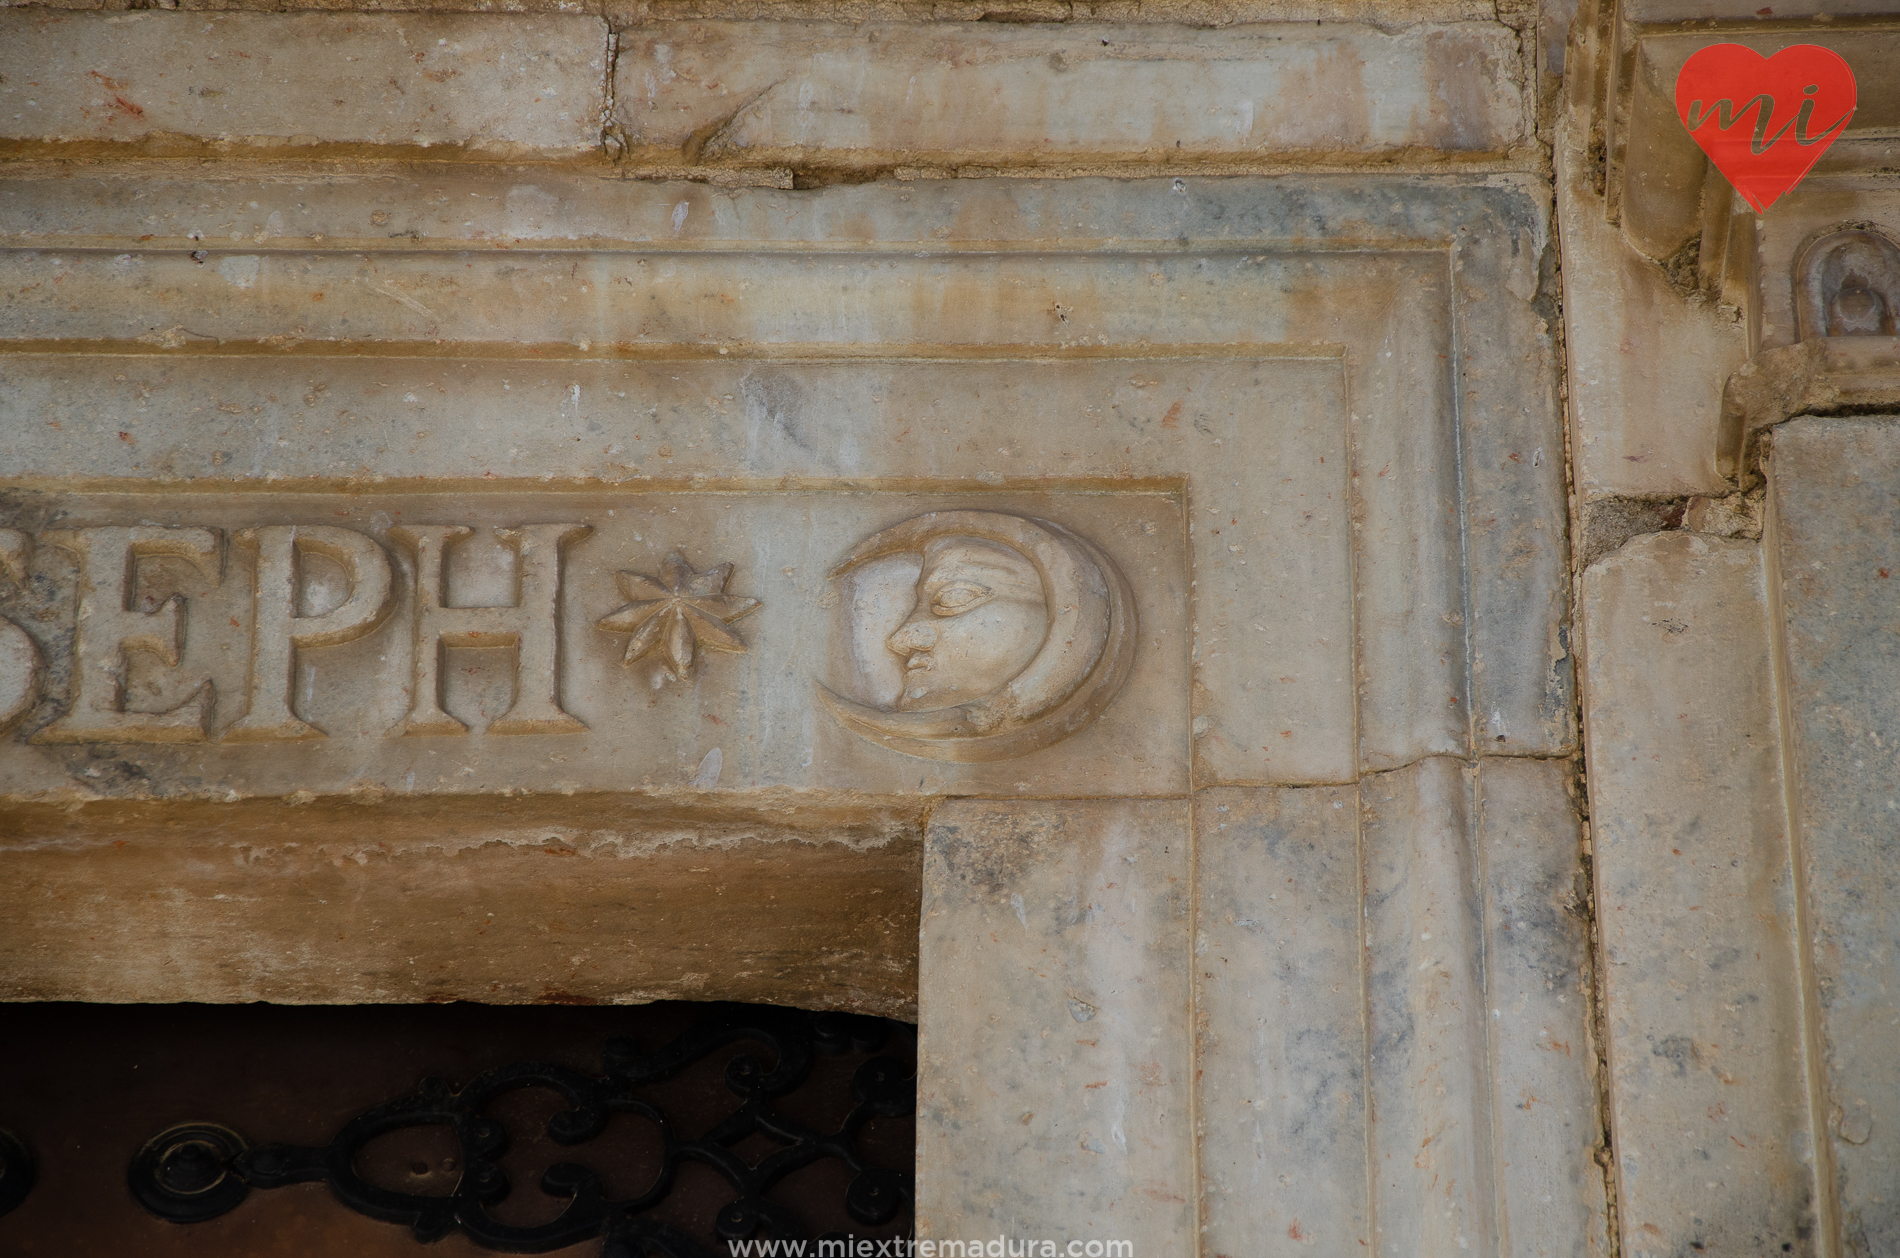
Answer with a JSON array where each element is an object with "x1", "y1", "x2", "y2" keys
[{"x1": 129, "y1": 1005, "x2": 916, "y2": 1258}]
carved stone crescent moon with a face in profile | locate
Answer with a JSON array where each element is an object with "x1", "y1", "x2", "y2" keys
[{"x1": 819, "y1": 511, "x2": 1136, "y2": 760}]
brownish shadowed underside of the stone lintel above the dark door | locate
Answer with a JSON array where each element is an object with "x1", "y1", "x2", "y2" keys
[{"x1": 0, "y1": 798, "x2": 922, "y2": 1017}]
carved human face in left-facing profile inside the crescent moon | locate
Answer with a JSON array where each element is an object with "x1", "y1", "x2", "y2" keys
[{"x1": 885, "y1": 536, "x2": 1049, "y2": 713}]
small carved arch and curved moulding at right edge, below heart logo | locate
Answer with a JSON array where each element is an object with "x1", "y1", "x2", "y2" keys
[{"x1": 1718, "y1": 222, "x2": 1900, "y2": 486}]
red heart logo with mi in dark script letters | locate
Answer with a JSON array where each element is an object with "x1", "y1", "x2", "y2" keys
[{"x1": 1676, "y1": 44, "x2": 1856, "y2": 215}]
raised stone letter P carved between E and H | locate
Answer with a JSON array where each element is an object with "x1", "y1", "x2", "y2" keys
[{"x1": 222, "y1": 524, "x2": 390, "y2": 743}]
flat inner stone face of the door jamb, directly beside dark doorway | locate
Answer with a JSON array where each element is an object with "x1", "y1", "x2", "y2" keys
[{"x1": 918, "y1": 800, "x2": 1195, "y2": 1254}]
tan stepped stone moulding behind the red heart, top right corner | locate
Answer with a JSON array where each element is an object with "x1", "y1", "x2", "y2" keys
[{"x1": 1573, "y1": 0, "x2": 1900, "y2": 310}]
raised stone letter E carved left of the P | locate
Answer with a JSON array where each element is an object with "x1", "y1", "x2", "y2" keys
[{"x1": 32, "y1": 524, "x2": 222, "y2": 743}]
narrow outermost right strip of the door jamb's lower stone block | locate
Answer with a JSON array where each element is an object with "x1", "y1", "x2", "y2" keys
[{"x1": 1478, "y1": 756, "x2": 1613, "y2": 1258}]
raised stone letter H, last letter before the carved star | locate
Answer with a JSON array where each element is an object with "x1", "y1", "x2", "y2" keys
[{"x1": 390, "y1": 524, "x2": 591, "y2": 734}]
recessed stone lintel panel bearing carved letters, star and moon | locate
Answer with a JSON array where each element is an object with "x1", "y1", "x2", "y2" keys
[{"x1": 0, "y1": 492, "x2": 1189, "y2": 798}]
